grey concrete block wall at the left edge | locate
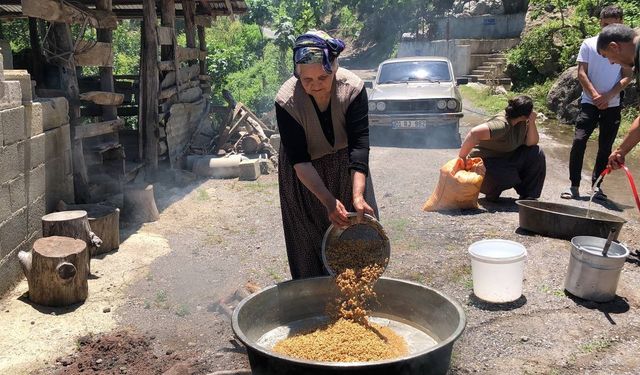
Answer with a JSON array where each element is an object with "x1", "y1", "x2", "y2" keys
[{"x1": 0, "y1": 60, "x2": 74, "y2": 295}]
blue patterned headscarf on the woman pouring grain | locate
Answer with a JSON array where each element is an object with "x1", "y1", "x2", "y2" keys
[{"x1": 293, "y1": 30, "x2": 345, "y2": 77}]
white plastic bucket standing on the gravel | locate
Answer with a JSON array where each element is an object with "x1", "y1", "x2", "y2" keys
[{"x1": 469, "y1": 240, "x2": 527, "y2": 303}]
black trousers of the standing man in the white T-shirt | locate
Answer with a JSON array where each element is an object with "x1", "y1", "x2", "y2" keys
[{"x1": 569, "y1": 103, "x2": 621, "y2": 186}]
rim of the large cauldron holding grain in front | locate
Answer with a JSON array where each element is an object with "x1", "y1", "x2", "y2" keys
[{"x1": 231, "y1": 276, "x2": 467, "y2": 369}]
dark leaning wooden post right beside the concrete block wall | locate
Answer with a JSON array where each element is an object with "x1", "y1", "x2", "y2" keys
[{"x1": 51, "y1": 22, "x2": 91, "y2": 203}]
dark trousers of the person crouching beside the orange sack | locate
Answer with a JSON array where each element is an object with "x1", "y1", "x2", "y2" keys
[{"x1": 480, "y1": 146, "x2": 547, "y2": 199}]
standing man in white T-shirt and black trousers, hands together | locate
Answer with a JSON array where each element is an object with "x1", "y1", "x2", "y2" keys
[{"x1": 560, "y1": 5, "x2": 632, "y2": 200}]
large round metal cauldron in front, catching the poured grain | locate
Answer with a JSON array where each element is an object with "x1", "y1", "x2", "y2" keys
[{"x1": 232, "y1": 277, "x2": 466, "y2": 375}]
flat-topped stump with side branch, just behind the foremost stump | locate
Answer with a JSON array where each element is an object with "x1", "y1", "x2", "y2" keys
[{"x1": 42, "y1": 210, "x2": 102, "y2": 255}]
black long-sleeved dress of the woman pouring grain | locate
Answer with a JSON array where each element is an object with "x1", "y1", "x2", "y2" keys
[{"x1": 276, "y1": 89, "x2": 378, "y2": 279}]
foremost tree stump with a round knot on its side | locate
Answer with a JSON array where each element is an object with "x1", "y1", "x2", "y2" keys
[{"x1": 18, "y1": 236, "x2": 89, "y2": 307}]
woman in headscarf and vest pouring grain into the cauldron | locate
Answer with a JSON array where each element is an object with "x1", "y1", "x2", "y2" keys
[{"x1": 275, "y1": 30, "x2": 377, "y2": 279}]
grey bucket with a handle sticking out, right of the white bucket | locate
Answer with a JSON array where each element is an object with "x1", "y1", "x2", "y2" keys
[{"x1": 564, "y1": 236, "x2": 629, "y2": 302}]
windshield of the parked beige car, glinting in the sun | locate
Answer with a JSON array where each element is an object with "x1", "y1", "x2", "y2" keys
[{"x1": 378, "y1": 61, "x2": 451, "y2": 84}]
